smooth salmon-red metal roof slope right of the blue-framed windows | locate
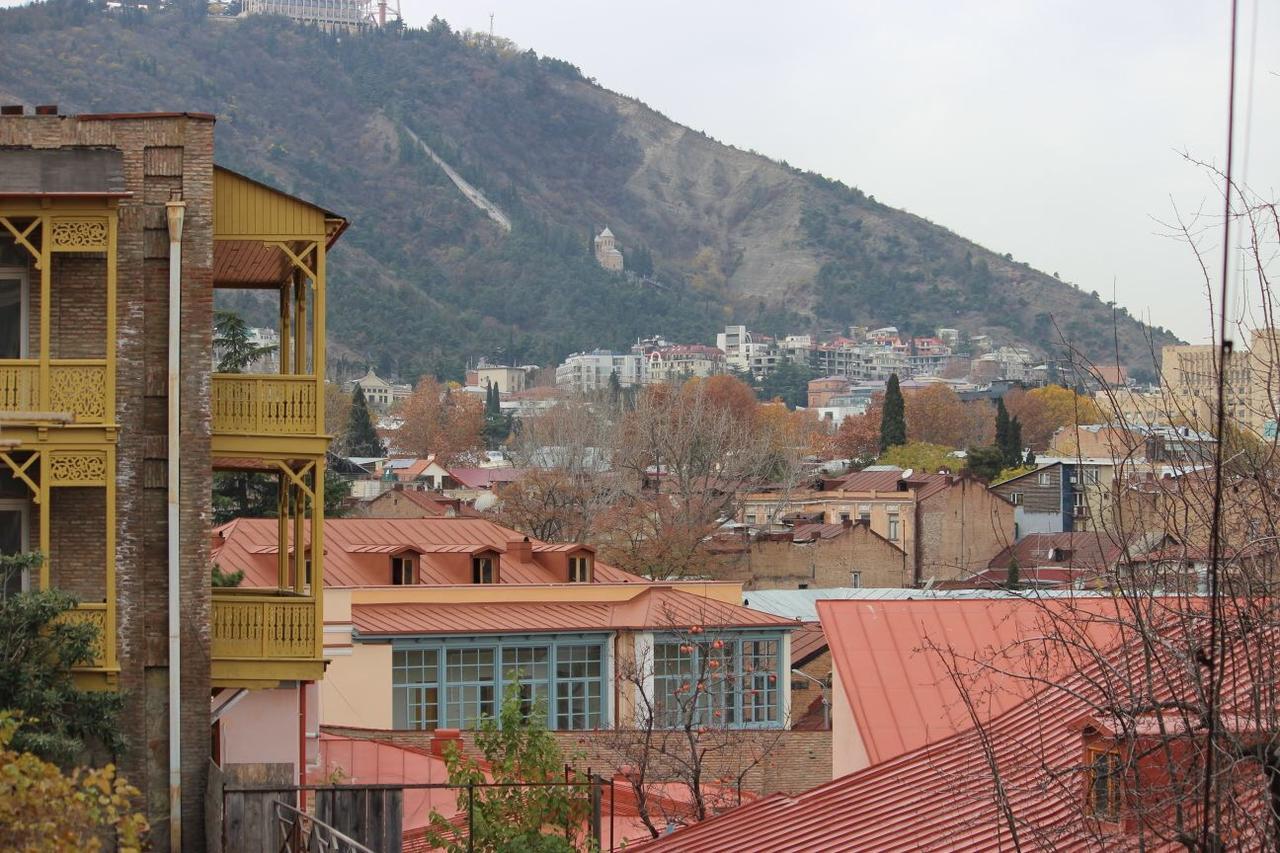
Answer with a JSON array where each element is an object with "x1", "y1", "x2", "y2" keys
[{"x1": 817, "y1": 597, "x2": 1116, "y2": 765}]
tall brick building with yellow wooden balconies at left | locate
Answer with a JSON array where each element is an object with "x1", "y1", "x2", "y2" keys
[{"x1": 0, "y1": 108, "x2": 347, "y2": 850}]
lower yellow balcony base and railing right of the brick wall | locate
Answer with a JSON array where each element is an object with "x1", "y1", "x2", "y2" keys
[{"x1": 210, "y1": 589, "x2": 324, "y2": 686}]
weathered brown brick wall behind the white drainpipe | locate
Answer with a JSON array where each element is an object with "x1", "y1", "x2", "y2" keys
[{"x1": 0, "y1": 115, "x2": 214, "y2": 850}]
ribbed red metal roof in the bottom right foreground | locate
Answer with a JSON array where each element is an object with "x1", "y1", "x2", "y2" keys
[{"x1": 636, "y1": 601, "x2": 1277, "y2": 853}]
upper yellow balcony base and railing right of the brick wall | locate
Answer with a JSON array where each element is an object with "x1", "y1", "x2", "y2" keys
[{"x1": 212, "y1": 373, "x2": 328, "y2": 456}]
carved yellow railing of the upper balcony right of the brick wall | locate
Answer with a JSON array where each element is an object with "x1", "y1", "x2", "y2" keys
[{"x1": 214, "y1": 373, "x2": 324, "y2": 435}]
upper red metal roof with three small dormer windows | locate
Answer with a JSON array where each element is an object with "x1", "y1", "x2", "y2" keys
[{"x1": 212, "y1": 516, "x2": 648, "y2": 587}]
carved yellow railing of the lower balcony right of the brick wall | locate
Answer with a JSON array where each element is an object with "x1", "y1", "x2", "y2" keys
[{"x1": 212, "y1": 589, "x2": 319, "y2": 661}]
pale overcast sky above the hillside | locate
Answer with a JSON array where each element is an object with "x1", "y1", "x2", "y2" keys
[{"x1": 414, "y1": 0, "x2": 1280, "y2": 341}]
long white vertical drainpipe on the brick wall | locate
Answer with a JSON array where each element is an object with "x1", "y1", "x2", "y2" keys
[{"x1": 165, "y1": 195, "x2": 187, "y2": 852}]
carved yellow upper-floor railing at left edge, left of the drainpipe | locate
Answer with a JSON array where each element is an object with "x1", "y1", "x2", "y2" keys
[{"x1": 0, "y1": 359, "x2": 110, "y2": 424}]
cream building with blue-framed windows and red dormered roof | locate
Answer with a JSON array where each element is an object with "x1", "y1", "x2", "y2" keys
[{"x1": 214, "y1": 517, "x2": 794, "y2": 730}]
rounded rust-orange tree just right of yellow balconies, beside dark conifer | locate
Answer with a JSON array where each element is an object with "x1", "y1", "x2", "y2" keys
[{"x1": 396, "y1": 377, "x2": 484, "y2": 465}]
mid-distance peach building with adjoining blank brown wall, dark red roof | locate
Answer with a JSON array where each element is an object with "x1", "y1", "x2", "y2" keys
[{"x1": 739, "y1": 466, "x2": 1014, "y2": 585}]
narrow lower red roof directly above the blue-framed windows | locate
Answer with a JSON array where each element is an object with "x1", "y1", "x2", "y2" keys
[{"x1": 351, "y1": 587, "x2": 795, "y2": 635}]
